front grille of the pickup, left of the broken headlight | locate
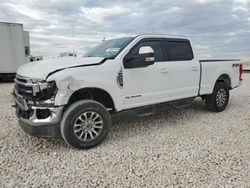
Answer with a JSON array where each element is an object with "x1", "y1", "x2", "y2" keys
[{"x1": 15, "y1": 75, "x2": 33, "y2": 98}]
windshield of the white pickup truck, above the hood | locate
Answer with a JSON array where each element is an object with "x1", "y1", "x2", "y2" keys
[{"x1": 85, "y1": 37, "x2": 134, "y2": 59}]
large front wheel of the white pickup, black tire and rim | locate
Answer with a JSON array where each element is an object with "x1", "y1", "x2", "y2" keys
[{"x1": 60, "y1": 100, "x2": 111, "y2": 149}]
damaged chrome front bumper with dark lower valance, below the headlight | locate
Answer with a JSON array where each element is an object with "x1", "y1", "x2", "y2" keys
[{"x1": 16, "y1": 105, "x2": 63, "y2": 138}]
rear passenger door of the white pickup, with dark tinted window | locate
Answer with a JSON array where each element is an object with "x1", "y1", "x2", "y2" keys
[{"x1": 163, "y1": 39, "x2": 200, "y2": 100}]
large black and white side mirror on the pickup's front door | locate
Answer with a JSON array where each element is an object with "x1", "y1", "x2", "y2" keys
[{"x1": 124, "y1": 46, "x2": 155, "y2": 68}]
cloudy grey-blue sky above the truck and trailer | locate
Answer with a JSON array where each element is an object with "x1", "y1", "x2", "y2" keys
[{"x1": 0, "y1": 0, "x2": 250, "y2": 58}]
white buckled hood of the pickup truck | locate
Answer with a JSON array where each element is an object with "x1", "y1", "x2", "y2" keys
[{"x1": 17, "y1": 57, "x2": 104, "y2": 80}]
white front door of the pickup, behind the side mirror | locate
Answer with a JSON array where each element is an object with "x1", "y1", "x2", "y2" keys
[{"x1": 123, "y1": 39, "x2": 170, "y2": 108}]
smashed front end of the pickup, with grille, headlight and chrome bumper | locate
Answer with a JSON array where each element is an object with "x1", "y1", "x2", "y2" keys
[{"x1": 13, "y1": 75, "x2": 63, "y2": 137}]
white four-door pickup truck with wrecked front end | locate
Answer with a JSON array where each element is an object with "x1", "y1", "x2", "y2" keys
[{"x1": 14, "y1": 35, "x2": 242, "y2": 149}]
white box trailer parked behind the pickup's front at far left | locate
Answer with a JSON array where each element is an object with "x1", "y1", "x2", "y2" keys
[{"x1": 0, "y1": 22, "x2": 30, "y2": 80}]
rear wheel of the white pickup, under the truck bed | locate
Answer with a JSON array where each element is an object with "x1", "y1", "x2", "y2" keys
[{"x1": 205, "y1": 82, "x2": 229, "y2": 112}]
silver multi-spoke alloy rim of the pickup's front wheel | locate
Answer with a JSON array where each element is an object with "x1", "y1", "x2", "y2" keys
[{"x1": 73, "y1": 111, "x2": 103, "y2": 141}]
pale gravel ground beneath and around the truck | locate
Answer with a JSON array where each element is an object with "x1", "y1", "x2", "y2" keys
[{"x1": 0, "y1": 74, "x2": 250, "y2": 187}]
